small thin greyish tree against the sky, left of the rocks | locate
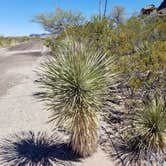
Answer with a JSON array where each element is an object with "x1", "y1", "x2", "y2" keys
[{"x1": 111, "y1": 6, "x2": 125, "y2": 24}]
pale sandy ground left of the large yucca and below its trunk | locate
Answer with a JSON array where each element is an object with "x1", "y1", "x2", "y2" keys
[{"x1": 0, "y1": 42, "x2": 114, "y2": 166}]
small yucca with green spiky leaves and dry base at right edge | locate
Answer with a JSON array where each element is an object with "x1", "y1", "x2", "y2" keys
[{"x1": 136, "y1": 99, "x2": 166, "y2": 152}]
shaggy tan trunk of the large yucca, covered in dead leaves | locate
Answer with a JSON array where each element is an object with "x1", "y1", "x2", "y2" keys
[{"x1": 70, "y1": 107, "x2": 98, "y2": 157}]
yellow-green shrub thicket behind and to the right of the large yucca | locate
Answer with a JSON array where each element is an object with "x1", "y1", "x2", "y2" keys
[{"x1": 48, "y1": 17, "x2": 166, "y2": 95}]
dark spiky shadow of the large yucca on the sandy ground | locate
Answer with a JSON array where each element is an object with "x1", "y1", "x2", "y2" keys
[{"x1": 0, "y1": 131, "x2": 79, "y2": 166}]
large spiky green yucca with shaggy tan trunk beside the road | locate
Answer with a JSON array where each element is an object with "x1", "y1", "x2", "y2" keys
[{"x1": 38, "y1": 39, "x2": 117, "y2": 157}]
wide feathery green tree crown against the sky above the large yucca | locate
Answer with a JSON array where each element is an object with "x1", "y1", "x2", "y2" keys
[{"x1": 33, "y1": 8, "x2": 85, "y2": 33}]
